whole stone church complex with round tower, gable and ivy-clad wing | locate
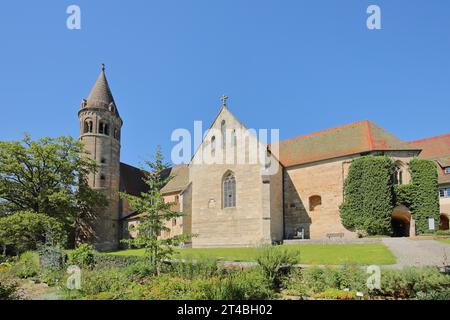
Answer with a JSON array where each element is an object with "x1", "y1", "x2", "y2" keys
[{"x1": 78, "y1": 67, "x2": 450, "y2": 250}]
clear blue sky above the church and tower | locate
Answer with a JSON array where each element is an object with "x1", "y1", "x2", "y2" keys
[{"x1": 0, "y1": 0, "x2": 450, "y2": 165}]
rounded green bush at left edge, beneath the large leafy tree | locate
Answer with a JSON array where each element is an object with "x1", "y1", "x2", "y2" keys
[{"x1": 0, "y1": 211, "x2": 67, "y2": 253}]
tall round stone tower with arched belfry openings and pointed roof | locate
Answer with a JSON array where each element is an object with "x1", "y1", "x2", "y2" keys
[{"x1": 78, "y1": 65, "x2": 123, "y2": 251}]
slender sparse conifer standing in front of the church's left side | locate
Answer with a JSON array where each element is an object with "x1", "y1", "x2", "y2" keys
[{"x1": 120, "y1": 146, "x2": 189, "y2": 274}]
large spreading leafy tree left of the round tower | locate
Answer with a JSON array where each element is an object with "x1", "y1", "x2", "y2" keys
[{"x1": 0, "y1": 134, "x2": 106, "y2": 229}]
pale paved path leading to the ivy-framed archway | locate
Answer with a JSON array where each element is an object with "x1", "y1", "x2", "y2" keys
[{"x1": 382, "y1": 238, "x2": 450, "y2": 268}]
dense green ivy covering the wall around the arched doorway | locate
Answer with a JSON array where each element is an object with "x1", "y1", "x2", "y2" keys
[{"x1": 340, "y1": 156, "x2": 439, "y2": 235}]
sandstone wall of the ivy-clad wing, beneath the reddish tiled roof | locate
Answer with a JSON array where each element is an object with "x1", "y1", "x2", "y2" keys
[{"x1": 284, "y1": 151, "x2": 417, "y2": 239}]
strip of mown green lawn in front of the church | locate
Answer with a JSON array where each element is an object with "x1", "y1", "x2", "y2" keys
[{"x1": 111, "y1": 243, "x2": 396, "y2": 265}]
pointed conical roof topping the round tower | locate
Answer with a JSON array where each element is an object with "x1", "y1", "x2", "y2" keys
[{"x1": 86, "y1": 65, "x2": 119, "y2": 115}]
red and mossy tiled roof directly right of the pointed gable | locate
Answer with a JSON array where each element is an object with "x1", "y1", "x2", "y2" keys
[{"x1": 272, "y1": 120, "x2": 416, "y2": 167}]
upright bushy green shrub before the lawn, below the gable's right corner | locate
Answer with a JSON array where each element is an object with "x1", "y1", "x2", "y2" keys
[{"x1": 256, "y1": 247, "x2": 299, "y2": 289}]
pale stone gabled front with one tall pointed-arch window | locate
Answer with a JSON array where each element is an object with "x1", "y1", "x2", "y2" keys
[{"x1": 189, "y1": 107, "x2": 282, "y2": 247}]
